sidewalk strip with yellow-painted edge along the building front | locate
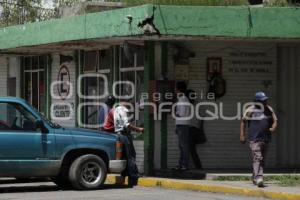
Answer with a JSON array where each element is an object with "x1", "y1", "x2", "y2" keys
[{"x1": 107, "y1": 175, "x2": 300, "y2": 200}]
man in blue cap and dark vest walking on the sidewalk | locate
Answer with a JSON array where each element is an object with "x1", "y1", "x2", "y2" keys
[{"x1": 240, "y1": 92, "x2": 277, "y2": 187}]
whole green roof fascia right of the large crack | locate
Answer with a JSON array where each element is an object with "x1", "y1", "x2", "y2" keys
[{"x1": 155, "y1": 6, "x2": 300, "y2": 38}]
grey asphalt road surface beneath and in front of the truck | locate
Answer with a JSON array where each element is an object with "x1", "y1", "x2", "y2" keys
[{"x1": 0, "y1": 180, "x2": 263, "y2": 200}]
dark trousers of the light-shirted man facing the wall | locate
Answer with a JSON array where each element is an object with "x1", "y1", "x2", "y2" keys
[{"x1": 176, "y1": 125, "x2": 190, "y2": 168}]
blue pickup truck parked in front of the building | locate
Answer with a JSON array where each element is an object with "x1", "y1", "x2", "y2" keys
[{"x1": 0, "y1": 97, "x2": 126, "y2": 190}]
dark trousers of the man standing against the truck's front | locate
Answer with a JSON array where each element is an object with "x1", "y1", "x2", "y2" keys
[{"x1": 118, "y1": 133, "x2": 138, "y2": 178}]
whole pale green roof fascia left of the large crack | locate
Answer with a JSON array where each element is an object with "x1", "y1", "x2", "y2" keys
[{"x1": 0, "y1": 5, "x2": 148, "y2": 49}]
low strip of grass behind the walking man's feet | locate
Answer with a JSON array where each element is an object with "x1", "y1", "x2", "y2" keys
[{"x1": 214, "y1": 175, "x2": 300, "y2": 187}]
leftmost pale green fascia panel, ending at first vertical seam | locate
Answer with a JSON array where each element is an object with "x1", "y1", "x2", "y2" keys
[{"x1": 0, "y1": 16, "x2": 85, "y2": 49}]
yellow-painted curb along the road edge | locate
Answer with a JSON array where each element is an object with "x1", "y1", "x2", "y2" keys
[{"x1": 106, "y1": 175, "x2": 300, "y2": 200}]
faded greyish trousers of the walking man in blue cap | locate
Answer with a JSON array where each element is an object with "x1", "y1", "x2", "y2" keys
[{"x1": 250, "y1": 141, "x2": 268, "y2": 180}]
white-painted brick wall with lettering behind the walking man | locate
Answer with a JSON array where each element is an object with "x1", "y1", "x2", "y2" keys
[{"x1": 168, "y1": 41, "x2": 277, "y2": 169}]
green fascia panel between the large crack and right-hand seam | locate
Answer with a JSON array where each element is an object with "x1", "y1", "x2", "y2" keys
[{"x1": 155, "y1": 6, "x2": 248, "y2": 37}]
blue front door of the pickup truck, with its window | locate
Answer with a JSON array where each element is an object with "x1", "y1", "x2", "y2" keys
[{"x1": 0, "y1": 102, "x2": 55, "y2": 177}]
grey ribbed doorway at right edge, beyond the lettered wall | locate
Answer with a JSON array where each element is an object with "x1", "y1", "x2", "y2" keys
[{"x1": 277, "y1": 45, "x2": 300, "y2": 168}]
